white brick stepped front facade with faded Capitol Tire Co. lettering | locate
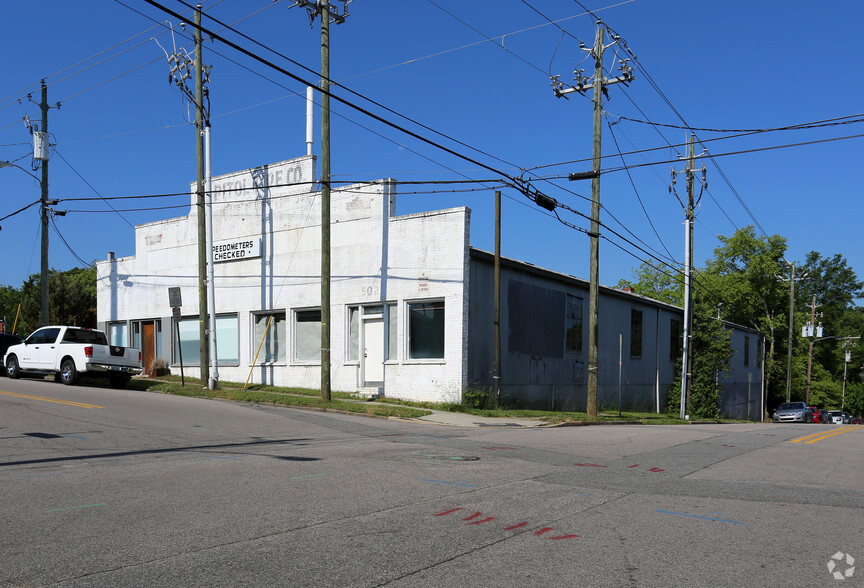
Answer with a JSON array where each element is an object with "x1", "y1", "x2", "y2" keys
[{"x1": 97, "y1": 156, "x2": 470, "y2": 401}]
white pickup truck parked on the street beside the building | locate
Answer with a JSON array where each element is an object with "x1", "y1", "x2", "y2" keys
[{"x1": 3, "y1": 326, "x2": 141, "y2": 388}]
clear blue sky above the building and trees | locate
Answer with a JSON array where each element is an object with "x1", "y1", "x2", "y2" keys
[{"x1": 0, "y1": 0, "x2": 864, "y2": 308}]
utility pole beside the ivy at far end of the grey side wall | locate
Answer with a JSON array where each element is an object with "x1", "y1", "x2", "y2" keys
[{"x1": 670, "y1": 133, "x2": 704, "y2": 419}]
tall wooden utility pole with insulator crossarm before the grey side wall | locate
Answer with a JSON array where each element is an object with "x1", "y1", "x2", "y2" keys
[{"x1": 552, "y1": 19, "x2": 633, "y2": 417}]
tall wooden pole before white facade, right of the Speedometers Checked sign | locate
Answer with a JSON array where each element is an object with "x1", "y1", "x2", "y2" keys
[{"x1": 294, "y1": 0, "x2": 351, "y2": 402}]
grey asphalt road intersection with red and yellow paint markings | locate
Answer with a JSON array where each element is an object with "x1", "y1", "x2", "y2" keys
[{"x1": 0, "y1": 378, "x2": 864, "y2": 588}]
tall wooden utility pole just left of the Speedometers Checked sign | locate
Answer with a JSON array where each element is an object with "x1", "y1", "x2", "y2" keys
[{"x1": 195, "y1": 4, "x2": 210, "y2": 386}]
